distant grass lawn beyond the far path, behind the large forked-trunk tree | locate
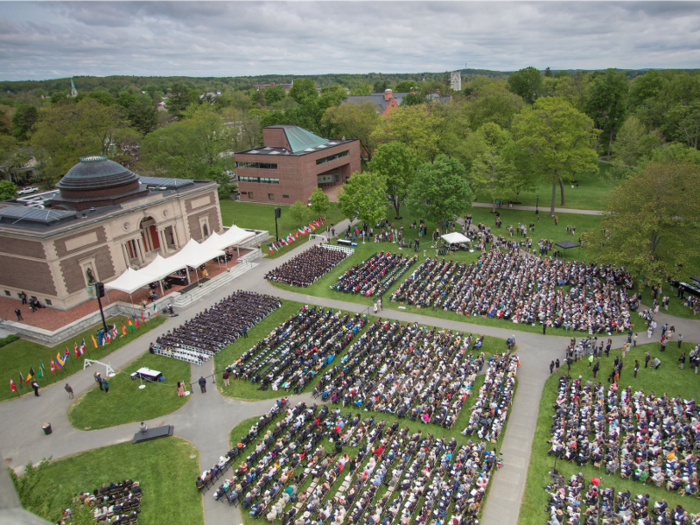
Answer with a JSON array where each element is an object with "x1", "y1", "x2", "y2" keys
[{"x1": 476, "y1": 162, "x2": 619, "y2": 213}]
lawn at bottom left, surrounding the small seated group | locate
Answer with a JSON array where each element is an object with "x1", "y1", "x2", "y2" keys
[{"x1": 14, "y1": 437, "x2": 204, "y2": 525}]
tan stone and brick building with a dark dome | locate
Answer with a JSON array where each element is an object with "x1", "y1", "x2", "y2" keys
[{"x1": 0, "y1": 157, "x2": 222, "y2": 310}]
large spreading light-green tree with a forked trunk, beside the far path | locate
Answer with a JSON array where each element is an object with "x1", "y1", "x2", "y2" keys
[{"x1": 513, "y1": 97, "x2": 598, "y2": 215}]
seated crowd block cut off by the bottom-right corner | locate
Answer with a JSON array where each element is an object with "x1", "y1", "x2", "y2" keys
[{"x1": 545, "y1": 473, "x2": 700, "y2": 525}]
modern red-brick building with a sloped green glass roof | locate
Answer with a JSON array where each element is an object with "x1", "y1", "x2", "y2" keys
[{"x1": 236, "y1": 126, "x2": 361, "y2": 204}]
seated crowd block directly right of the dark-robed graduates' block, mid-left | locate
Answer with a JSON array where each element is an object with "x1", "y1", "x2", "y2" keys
[{"x1": 227, "y1": 306, "x2": 366, "y2": 393}]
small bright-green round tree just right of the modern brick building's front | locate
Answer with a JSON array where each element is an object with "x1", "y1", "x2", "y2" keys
[{"x1": 338, "y1": 171, "x2": 386, "y2": 225}]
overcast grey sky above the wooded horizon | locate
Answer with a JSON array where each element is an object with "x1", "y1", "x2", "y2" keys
[{"x1": 0, "y1": 0, "x2": 700, "y2": 80}]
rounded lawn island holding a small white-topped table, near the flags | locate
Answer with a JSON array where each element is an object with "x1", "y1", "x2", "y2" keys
[{"x1": 68, "y1": 353, "x2": 191, "y2": 430}]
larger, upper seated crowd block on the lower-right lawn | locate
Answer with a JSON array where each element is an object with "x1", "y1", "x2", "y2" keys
[{"x1": 549, "y1": 376, "x2": 700, "y2": 496}]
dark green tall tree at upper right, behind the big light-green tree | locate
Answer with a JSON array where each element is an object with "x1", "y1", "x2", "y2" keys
[{"x1": 586, "y1": 69, "x2": 628, "y2": 160}]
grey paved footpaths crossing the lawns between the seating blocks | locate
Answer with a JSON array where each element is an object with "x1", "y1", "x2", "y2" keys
[{"x1": 0, "y1": 221, "x2": 700, "y2": 525}]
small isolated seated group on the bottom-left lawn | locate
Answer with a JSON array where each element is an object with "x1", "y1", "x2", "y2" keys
[{"x1": 58, "y1": 479, "x2": 142, "y2": 525}]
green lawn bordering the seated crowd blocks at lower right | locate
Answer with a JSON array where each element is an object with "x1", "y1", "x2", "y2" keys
[{"x1": 518, "y1": 334, "x2": 700, "y2": 525}]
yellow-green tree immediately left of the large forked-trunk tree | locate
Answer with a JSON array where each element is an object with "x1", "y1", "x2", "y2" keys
[{"x1": 468, "y1": 122, "x2": 515, "y2": 212}]
